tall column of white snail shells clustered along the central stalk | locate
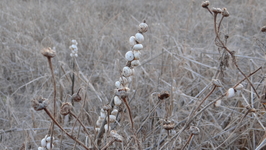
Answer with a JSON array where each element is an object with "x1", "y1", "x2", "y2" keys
[{"x1": 95, "y1": 21, "x2": 148, "y2": 132}]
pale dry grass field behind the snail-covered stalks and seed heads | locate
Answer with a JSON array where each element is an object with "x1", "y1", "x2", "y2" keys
[{"x1": 0, "y1": 0, "x2": 266, "y2": 150}]
